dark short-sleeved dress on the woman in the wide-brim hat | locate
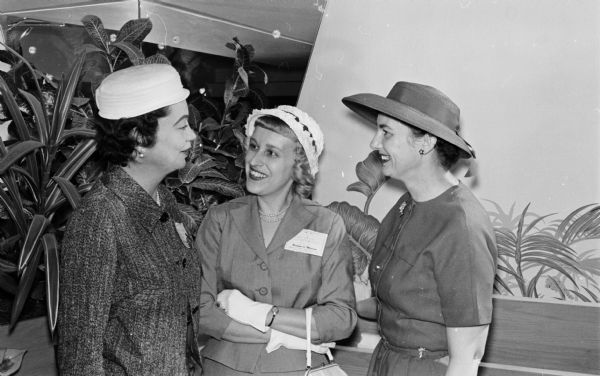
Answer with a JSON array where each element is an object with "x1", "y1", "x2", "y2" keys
[{"x1": 368, "y1": 183, "x2": 497, "y2": 376}]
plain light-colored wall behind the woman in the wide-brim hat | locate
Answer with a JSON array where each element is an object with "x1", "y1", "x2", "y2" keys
[{"x1": 298, "y1": 0, "x2": 600, "y2": 218}]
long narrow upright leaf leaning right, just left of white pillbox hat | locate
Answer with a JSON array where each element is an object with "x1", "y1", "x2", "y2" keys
[{"x1": 50, "y1": 54, "x2": 85, "y2": 145}]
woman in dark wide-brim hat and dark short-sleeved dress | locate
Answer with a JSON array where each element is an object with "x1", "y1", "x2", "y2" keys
[{"x1": 342, "y1": 82, "x2": 497, "y2": 376}]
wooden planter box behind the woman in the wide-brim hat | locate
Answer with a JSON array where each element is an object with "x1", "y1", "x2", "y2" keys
[{"x1": 334, "y1": 295, "x2": 600, "y2": 376}]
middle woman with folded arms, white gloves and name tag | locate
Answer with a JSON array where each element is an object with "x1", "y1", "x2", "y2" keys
[{"x1": 196, "y1": 106, "x2": 357, "y2": 376}]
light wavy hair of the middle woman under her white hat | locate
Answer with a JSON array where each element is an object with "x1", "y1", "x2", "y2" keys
[{"x1": 255, "y1": 115, "x2": 315, "y2": 198}]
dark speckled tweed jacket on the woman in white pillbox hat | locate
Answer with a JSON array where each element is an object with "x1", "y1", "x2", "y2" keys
[{"x1": 57, "y1": 168, "x2": 202, "y2": 376}]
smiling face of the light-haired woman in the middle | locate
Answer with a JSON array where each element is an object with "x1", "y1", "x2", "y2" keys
[{"x1": 245, "y1": 127, "x2": 296, "y2": 201}]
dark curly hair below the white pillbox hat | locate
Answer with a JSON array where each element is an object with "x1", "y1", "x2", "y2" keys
[{"x1": 96, "y1": 107, "x2": 169, "y2": 167}]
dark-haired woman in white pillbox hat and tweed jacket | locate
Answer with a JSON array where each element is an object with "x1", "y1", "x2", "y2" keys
[{"x1": 57, "y1": 64, "x2": 201, "y2": 375}]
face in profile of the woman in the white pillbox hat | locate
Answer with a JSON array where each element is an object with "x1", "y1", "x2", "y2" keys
[{"x1": 144, "y1": 100, "x2": 196, "y2": 176}]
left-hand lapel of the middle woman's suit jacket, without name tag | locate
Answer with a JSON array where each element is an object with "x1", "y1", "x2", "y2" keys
[{"x1": 231, "y1": 196, "x2": 267, "y2": 262}]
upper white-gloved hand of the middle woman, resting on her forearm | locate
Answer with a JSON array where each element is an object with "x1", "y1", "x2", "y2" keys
[{"x1": 217, "y1": 290, "x2": 273, "y2": 333}]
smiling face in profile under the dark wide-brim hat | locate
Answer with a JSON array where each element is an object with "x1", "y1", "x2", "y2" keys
[{"x1": 370, "y1": 114, "x2": 421, "y2": 181}]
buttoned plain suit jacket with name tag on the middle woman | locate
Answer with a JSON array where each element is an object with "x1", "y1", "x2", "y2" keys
[{"x1": 196, "y1": 195, "x2": 357, "y2": 372}]
